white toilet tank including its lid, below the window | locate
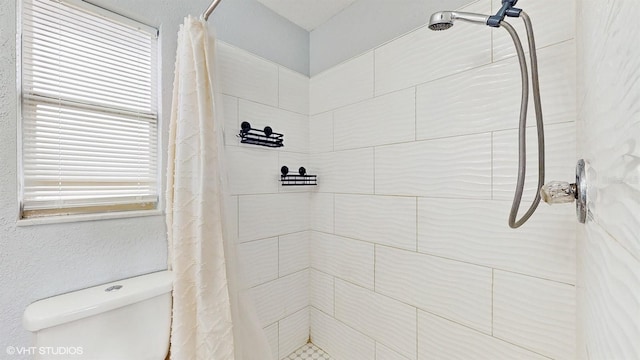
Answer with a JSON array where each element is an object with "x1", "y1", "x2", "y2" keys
[{"x1": 23, "y1": 271, "x2": 173, "y2": 360}]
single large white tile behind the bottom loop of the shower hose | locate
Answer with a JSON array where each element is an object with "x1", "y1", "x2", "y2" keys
[{"x1": 418, "y1": 198, "x2": 576, "y2": 283}]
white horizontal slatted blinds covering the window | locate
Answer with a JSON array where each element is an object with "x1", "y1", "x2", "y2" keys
[{"x1": 21, "y1": 0, "x2": 158, "y2": 218}]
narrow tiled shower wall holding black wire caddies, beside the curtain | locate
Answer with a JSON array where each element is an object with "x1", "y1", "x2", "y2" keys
[{"x1": 218, "y1": 42, "x2": 310, "y2": 359}]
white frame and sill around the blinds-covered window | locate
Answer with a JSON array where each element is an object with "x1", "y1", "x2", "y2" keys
[{"x1": 16, "y1": 0, "x2": 164, "y2": 226}]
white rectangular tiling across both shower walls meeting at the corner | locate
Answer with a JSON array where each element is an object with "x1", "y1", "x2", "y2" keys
[{"x1": 219, "y1": 0, "x2": 576, "y2": 360}]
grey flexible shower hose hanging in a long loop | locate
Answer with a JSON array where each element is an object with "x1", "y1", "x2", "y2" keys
[{"x1": 500, "y1": 11, "x2": 545, "y2": 229}]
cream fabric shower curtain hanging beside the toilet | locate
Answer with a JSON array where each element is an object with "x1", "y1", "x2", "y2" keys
[{"x1": 166, "y1": 17, "x2": 271, "y2": 360}]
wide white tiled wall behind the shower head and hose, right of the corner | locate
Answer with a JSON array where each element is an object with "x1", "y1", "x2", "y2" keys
[{"x1": 310, "y1": 0, "x2": 576, "y2": 360}]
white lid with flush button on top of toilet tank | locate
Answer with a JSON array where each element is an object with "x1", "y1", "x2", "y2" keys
[{"x1": 22, "y1": 271, "x2": 173, "y2": 331}]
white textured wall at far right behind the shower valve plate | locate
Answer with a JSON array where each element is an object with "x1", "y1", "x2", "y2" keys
[{"x1": 578, "y1": 0, "x2": 640, "y2": 360}]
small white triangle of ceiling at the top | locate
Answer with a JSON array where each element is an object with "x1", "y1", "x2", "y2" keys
[{"x1": 258, "y1": 0, "x2": 356, "y2": 31}]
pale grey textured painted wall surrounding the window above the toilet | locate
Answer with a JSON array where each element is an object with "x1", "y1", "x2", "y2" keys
[{"x1": 0, "y1": 0, "x2": 180, "y2": 351}]
